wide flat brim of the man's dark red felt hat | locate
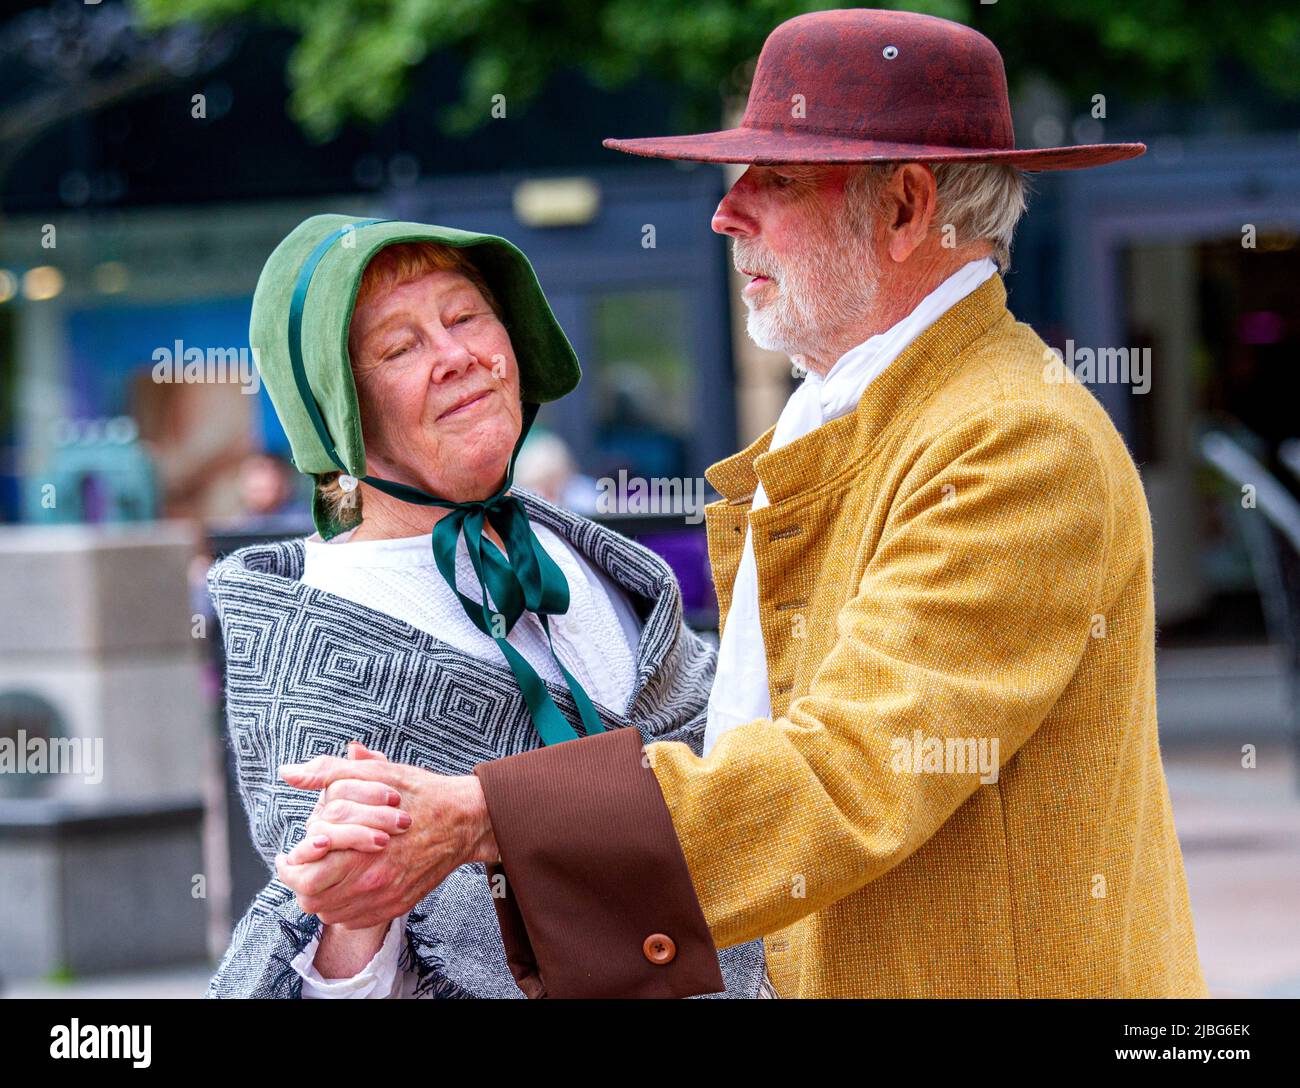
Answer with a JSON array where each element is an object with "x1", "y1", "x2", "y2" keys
[{"x1": 602, "y1": 127, "x2": 1147, "y2": 170}]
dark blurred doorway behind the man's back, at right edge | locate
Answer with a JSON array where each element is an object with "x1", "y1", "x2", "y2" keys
[{"x1": 1061, "y1": 136, "x2": 1300, "y2": 631}]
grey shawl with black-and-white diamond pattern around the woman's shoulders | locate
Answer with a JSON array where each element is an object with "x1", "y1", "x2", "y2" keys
[{"x1": 208, "y1": 490, "x2": 763, "y2": 998}]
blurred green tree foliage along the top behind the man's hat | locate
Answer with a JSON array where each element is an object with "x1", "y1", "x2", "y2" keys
[{"x1": 133, "y1": 0, "x2": 1300, "y2": 139}]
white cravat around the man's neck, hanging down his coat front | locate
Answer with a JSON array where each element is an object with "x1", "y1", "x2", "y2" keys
[{"x1": 705, "y1": 257, "x2": 997, "y2": 755}]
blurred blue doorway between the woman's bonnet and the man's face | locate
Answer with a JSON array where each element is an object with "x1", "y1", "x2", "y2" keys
[{"x1": 391, "y1": 166, "x2": 736, "y2": 477}]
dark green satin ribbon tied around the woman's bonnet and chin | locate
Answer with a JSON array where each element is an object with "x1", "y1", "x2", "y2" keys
[{"x1": 289, "y1": 220, "x2": 605, "y2": 745}]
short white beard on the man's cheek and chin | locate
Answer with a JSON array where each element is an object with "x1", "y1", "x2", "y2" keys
[{"x1": 735, "y1": 224, "x2": 879, "y2": 365}]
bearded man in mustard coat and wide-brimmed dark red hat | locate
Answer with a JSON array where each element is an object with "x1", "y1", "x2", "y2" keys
[{"x1": 280, "y1": 10, "x2": 1205, "y2": 997}]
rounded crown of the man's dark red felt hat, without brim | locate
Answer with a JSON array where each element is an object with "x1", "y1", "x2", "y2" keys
[{"x1": 741, "y1": 9, "x2": 1015, "y2": 149}]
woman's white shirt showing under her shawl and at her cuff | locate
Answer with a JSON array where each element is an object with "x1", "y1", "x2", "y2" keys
[{"x1": 293, "y1": 523, "x2": 641, "y2": 998}]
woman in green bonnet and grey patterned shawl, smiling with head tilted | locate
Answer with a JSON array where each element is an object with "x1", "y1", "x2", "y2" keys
[{"x1": 208, "y1": 216, "x2": 763, "y2": 997}]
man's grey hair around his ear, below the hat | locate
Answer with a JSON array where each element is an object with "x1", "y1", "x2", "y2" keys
[{"x1": 846, "y1": 162, "x2": 1028, "y2": 272}]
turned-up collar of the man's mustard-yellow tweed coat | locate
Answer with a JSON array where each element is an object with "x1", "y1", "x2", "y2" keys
[{"x1": 705, "y1": 276, "x2": 1010, "y2": 503}]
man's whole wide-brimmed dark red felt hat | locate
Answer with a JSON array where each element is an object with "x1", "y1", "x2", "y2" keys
[{"x1": 605, "y1": 8, "x2": 1147, "y2": 170}]
